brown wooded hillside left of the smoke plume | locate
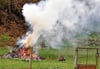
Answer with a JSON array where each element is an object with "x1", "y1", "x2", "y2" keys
[{"x1": 0, "y1": 0, "x2": 39, "y2": 46}]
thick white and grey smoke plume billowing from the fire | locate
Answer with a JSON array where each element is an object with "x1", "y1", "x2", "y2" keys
[{"x1": 17, "y1": 0, "x2": 100, "y2": 47}]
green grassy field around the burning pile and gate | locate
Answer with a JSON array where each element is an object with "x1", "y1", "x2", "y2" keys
[{"x1": 0, "y1": 47, "x2": 100, "y2": 69}]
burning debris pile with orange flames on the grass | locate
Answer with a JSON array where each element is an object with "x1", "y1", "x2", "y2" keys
[{"x1": 4, "y1": 47, "x2": 41, "y2": 60}]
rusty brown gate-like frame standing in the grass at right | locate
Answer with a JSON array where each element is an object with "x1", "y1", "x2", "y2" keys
[{"x1": 75, "y1": 47, "x2": 99, "y2": 69}]
